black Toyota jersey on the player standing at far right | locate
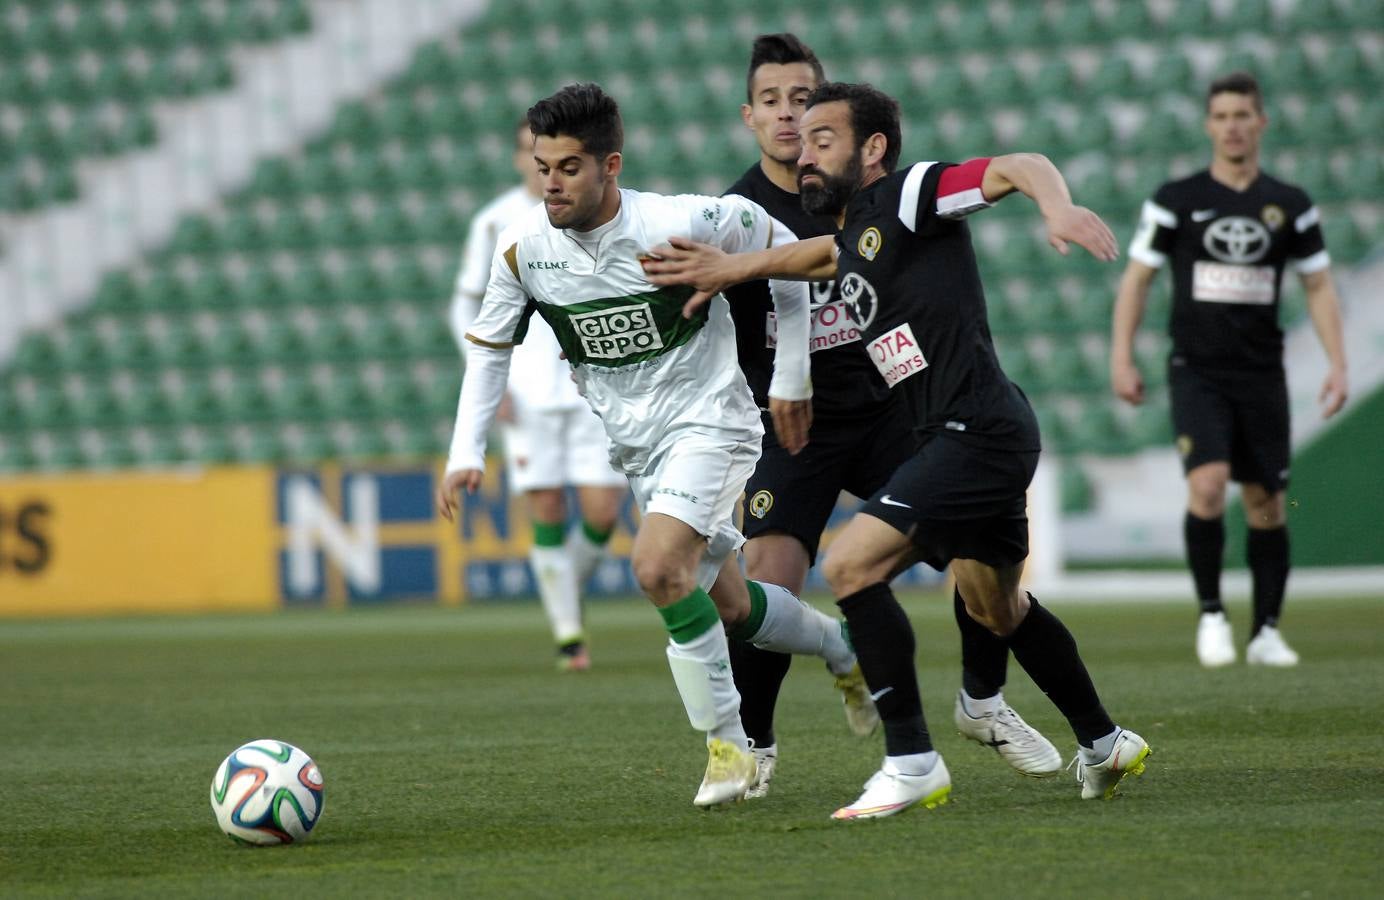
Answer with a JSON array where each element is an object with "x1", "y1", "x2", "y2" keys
[{"x1": 1129, "y1": 170, "x2": 1330, "y2": 370}]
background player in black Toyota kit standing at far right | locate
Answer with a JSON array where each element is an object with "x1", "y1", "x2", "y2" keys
[{"x1": 1110, "y1": 72, "x2": 1347, "y2": 666}]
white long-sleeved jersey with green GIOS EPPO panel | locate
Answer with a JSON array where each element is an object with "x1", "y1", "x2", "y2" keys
[{"x1": 447, "y1": 190, "x2": 811, "y2": 475}]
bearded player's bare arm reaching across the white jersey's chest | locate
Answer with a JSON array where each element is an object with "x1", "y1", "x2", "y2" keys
[{"x1": 639, "y1": 235, "x2": 836, "y2": 316}]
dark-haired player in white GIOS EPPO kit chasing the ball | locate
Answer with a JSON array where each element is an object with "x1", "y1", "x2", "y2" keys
[{"x1": 437, "y1": 84, "x2": 869, "y2": 806}]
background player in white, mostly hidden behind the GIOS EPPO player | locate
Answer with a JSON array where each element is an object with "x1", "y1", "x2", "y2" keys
[{"x1": 448, "y1": 120, "x2": 627, "y2": 672}]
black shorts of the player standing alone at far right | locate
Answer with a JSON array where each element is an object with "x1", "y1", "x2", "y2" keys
[{"x1": 1168, "y1": 361, "x2": 1291, "y2": 493}]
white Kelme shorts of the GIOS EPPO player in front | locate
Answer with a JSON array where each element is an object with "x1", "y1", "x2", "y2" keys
[{"x1": 630, "y1": 431, "x2": 760, "y2": 591}]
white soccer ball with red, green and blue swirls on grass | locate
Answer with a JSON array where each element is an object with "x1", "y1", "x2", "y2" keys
[{"x1": 212, "y1": 741, "x2": 322, "y2": 845}]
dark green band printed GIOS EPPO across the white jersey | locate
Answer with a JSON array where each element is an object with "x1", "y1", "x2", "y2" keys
[{"x1": 528, "y1": 287, "x2": 707, "y2": 368}]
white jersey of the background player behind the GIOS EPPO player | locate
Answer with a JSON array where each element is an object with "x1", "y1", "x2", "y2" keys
[{"x1": 450, "y1": 184, "x2": 575, "y2": 411}]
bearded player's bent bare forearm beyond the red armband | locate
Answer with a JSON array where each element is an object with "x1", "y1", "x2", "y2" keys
[{"x1": 980, "y1": 154, "x2": 1120, "y2": 262}]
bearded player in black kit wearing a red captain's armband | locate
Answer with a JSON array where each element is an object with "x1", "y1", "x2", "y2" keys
[{"x1": 650, "y1": 83, "x2": 1149, "y2": 820}]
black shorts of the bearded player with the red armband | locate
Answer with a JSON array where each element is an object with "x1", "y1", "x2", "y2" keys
[{"x1": 861, "y1": 435, "x2": 1038, "y2": 572}]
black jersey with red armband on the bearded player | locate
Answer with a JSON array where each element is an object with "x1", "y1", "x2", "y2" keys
[{"x1": 836, "y1": 159, "x2": 1039, "y2": 451}]
